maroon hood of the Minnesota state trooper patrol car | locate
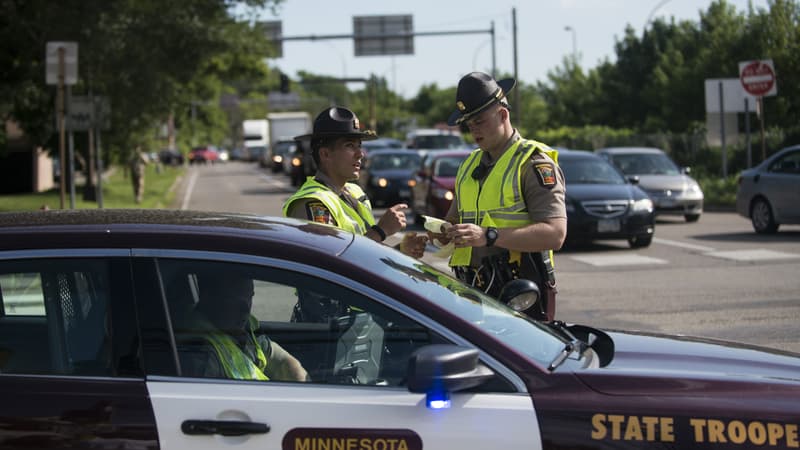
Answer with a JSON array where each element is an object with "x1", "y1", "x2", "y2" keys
[{"x1": 577, "y1": 331, "x2": 800, "y2": 395}]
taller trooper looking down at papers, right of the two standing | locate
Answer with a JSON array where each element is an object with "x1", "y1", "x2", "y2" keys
[{"x1": 430, "y1": 72, "x2": 567, "y2": 320}]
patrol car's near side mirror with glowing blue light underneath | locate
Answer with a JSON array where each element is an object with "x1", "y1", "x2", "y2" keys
[{"x1": 406, "y1": 344, "x2": 494, "y2": 399}]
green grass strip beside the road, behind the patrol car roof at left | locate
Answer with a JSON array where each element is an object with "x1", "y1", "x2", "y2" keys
[{"x1": 0, "y1": 164, "x2": 186, "y2": 211}]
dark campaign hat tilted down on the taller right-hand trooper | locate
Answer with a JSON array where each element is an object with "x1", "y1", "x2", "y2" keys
[{"x1": 447, "y1": 72, "x2": 517, "y2": 126}]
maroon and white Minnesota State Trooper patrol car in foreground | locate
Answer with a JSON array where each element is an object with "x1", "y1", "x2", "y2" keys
[{"x1": 0, "y1": 210, "x2": 800, "y2": 450}]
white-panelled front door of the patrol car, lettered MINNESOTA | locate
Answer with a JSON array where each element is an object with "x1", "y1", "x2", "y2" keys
[{"x1": 137, "y1": 253, "x2": 541, "y2": 450}]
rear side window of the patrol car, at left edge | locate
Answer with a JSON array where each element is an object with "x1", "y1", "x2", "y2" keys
[{"x1": 0, "y1": 259, "x2": 114, "y2": 376}]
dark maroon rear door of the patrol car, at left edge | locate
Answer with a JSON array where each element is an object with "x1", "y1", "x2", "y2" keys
[{"x1": 0, "y1": 249, "x2": 158, "y2": 449}]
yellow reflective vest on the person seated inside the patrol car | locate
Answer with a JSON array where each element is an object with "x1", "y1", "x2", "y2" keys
[{"x1": 204, "y1": 316, "x2": 269, "y2": 381}]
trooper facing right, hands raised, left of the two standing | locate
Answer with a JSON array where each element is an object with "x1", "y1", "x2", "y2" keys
[{"x1": 283, "y1": 107, "x2": 428, "y2": 257}]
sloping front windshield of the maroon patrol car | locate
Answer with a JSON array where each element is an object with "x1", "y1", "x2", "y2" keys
[{"x1": 343, "y1": 246, "x2": 567, "y2": 367}]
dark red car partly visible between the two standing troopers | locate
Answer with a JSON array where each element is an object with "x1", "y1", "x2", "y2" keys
[{"x1": 411, "y1": 150, "x2": 471, "y2": 223}]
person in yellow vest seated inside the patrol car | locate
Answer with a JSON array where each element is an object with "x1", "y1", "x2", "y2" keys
[{"x1": 182, "y1": 273, "x2": 308, "y2": 381}]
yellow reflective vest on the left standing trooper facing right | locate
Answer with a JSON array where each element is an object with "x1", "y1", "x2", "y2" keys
[{"x1": 283, "y1": 177, "x2": 375, "y2": 235}]
